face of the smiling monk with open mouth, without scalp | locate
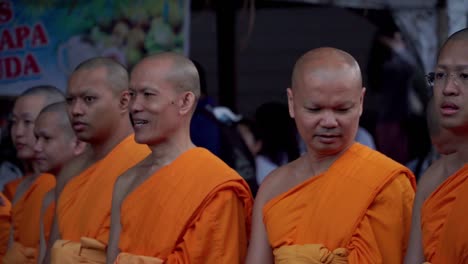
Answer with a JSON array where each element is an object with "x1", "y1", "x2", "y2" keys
[{"x1": 129, "y1": 61, "x2": 183, "y2": 145}]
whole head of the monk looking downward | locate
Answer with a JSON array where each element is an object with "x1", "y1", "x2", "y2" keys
[{"x1": 287, "y1": 48, "x2": 365, "y2": 156}]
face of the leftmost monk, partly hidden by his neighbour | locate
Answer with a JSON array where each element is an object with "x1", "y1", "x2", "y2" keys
[{"x1": 11, "y1": 95, "x2": 45, "y2": 160}]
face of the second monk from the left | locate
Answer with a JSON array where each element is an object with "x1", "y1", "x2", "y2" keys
[{"x1": 34, "y1": 112, "x2": 76, "y2": 175}]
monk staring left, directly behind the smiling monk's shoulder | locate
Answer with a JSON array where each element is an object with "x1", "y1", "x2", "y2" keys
[{"x1": 46, "y1": 58, "x2": 150, "y2": 264}]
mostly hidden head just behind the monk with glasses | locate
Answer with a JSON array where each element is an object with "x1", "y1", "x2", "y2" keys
[{"x1": 426, "y1": 98, "x2": 456, "y2": 155}]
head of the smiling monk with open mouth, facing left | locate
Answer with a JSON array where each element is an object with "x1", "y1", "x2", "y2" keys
[{"x1": 130, "y1": 52, "x2": 200, "y2": 145}]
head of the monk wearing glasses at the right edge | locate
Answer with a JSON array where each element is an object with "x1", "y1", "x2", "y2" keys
[{"x1": 433, "y1": 28, "x2": 468, "y2": 135}]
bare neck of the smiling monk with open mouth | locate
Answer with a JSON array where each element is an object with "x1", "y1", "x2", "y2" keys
[{"x1": 146, "y1": 136, "x2": 196, "y2": 167}]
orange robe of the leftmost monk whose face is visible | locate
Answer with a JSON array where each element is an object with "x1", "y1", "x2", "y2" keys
[{"x1": 4, "y1": 173, "x2": 55, "y2": 263}]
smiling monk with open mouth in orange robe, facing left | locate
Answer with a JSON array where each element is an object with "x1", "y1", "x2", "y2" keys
[{"x1": 108, "y1": 53, "x2": 253, "y2": 264}]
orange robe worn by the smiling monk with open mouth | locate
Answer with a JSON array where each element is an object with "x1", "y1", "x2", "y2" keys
[{"x1": 116, "y1": 148, "x2": 253, "y2": 264}]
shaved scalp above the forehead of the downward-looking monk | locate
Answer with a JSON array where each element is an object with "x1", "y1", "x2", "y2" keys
[{"x1": 292, "y1": 47, "x2": 362, "y2": 89}]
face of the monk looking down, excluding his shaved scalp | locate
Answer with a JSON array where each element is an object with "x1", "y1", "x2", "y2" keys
[{"x1": 288, "y1": 70, "x2": 365, "y2": 156}]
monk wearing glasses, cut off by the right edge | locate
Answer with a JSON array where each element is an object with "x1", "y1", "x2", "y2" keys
[{"x1": 406, "y1": 28, "x2": 468, "y2": 264}]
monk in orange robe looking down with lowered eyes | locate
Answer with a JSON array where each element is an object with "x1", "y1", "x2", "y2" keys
[{"x1": 247, "y1": 48, "x2": 415, "y2": 264}]
